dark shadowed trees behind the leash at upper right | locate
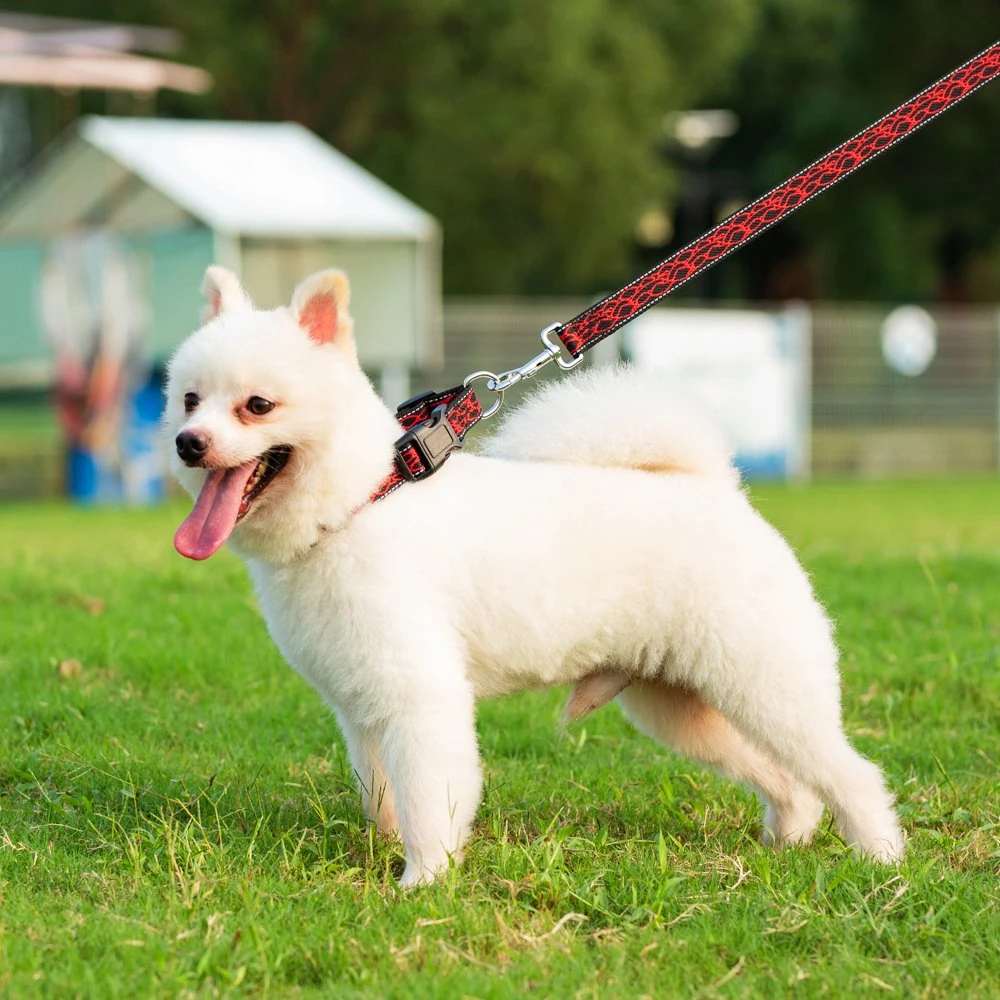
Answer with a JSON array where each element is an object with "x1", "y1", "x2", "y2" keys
[{"x1": 716, "y1": 0, "x2": 1000, "y2": 301}]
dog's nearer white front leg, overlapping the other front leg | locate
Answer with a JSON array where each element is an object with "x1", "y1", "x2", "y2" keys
[{"x1": 382, "y1": 679, "x2": 483, "y2": 889}]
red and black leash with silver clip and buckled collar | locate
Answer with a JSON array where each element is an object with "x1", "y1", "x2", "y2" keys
[{"x1": 371, "y1": 42, "x2": 1000, "y2": 501}]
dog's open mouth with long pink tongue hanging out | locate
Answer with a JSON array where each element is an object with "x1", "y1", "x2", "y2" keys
[{"x1": 174, "y1": 444, "x2": 292, "y2": 559}]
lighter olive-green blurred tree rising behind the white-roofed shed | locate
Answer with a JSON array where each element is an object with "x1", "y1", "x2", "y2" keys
[{"x1": 11, "y1": 0, "x2": 756, "y2": 293}]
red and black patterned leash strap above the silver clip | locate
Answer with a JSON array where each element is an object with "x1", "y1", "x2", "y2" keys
[{"x1": 556, "y1": 42, "x2": 1000, "y2": 358}]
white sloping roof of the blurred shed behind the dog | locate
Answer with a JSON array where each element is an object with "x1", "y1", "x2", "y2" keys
[{"x1": 0, "y1": 116, "x2": 438, "y2": 240}]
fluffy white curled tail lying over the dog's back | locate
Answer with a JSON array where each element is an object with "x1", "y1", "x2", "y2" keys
[{"x1": 484, "y1": 365, "x2": 739, "y2": 486}]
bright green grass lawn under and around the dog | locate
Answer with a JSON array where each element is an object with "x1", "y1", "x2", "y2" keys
[{"x1": 0, "y1": 481, "x2": 1000, "y2": 1000}]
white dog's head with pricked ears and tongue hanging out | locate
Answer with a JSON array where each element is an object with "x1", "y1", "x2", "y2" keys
[{"x1": 164, "y1": 267, "x2": 398, "y2": 561}]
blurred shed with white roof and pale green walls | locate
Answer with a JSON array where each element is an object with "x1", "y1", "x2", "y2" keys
[{"x1": 0, "y1": 117, "x2": 441, "y2": 380}]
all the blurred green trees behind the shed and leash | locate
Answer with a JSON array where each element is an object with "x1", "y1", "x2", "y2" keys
[{"x1": 1, "y1": 0, "x2": 1000, "y2": 301}]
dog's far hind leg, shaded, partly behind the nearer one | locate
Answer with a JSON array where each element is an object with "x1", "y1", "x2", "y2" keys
[{"x1": 618, "y1": 682, "x2": 823, "y2": 845}]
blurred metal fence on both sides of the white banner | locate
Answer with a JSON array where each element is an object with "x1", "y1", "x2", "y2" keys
[{"x1": 428, "y1": 299, "x2": 1000, "y2": 477}]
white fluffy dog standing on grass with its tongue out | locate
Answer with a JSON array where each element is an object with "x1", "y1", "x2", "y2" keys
[{"x1": 164, "y1": 267, "x2": 903, "y2": 886}]
